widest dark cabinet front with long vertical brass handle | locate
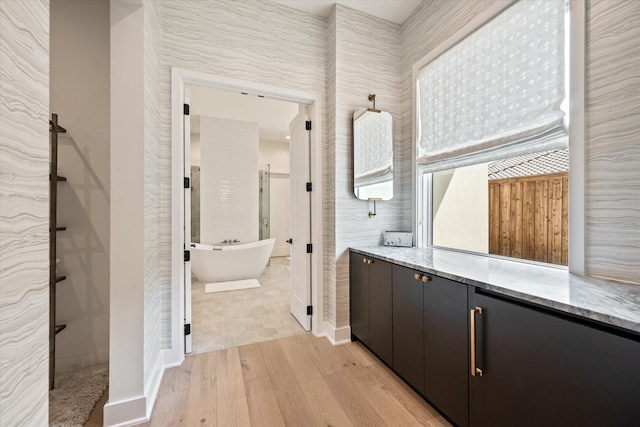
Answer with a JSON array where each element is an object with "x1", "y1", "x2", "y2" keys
[{"x1": 468, "y1": 288, "x2": 640, "y2": 427}]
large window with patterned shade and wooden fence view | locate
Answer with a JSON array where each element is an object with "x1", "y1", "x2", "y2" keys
[{"x1": 414, "y1": 0, "x2": 569, "y2": 265}]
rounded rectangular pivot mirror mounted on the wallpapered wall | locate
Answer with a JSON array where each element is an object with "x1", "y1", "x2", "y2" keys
[{"x1": 353, "y1": 108, "x2": 393, "y2": 200}]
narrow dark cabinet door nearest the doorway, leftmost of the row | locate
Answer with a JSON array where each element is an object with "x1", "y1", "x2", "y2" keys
[{"x1": 349, "y1": 252, "x2": 371, "y2": 347}]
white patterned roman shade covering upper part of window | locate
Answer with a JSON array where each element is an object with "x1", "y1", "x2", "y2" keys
[{"x1": 417, "y1": 0, "x2": 568, "y2": 172}]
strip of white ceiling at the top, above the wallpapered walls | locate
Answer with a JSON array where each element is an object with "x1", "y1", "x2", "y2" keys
[{"x1": 272, "y1": 0, "x2": 422, "y2": 24}]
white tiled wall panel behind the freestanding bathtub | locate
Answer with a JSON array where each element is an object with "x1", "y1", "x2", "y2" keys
[{"x1": 200, "y1": 116, "x2": 258, "y2": 244}]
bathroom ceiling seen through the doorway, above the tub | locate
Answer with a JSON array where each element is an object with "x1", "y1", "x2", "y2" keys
[{"x1": 189, "y1": 86, "x2": 298, "y2": 142}]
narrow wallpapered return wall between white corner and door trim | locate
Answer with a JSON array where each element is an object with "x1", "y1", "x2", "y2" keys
[{"x1": 143, "y1": 0, "x2": 164, "y2": 386}]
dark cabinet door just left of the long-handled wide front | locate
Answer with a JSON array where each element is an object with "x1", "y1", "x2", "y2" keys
[{"x1": 424, "y1": 276, "x2": 469, "y2": 426}]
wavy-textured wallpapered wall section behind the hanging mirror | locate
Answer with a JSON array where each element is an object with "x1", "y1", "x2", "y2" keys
[{"x1": 329, "y1": 5, "x2": 402, "y2": 328}]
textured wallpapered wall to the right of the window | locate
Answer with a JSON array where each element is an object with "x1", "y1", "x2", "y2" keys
[{"x1": 585, "y1": 0, "x2": 640, "y2": 284}]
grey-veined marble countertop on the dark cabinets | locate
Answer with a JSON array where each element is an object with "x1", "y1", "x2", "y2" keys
[{"x1": 351, "y1": 246, "x2": 640, "y2": 333}]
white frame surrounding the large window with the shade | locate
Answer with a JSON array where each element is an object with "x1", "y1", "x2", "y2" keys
[{"x1": 411, "y1": 0, "x2": 586, "y2": 275}]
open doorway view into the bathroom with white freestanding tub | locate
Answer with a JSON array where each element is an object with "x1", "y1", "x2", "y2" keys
[{"x1": 185, "y1": 85, "x2": 310, "y2": 353}]
